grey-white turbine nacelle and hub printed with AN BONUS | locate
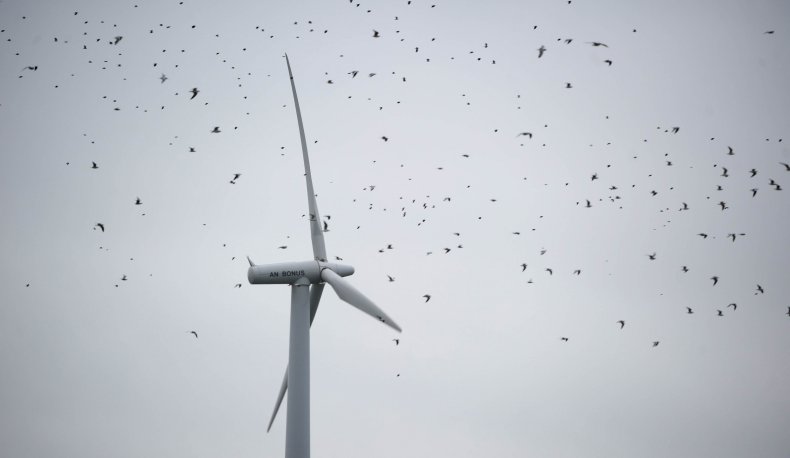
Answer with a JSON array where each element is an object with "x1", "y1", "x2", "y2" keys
[{"x1": 247, "y1": 261, "x2": 354, "y2": 285}]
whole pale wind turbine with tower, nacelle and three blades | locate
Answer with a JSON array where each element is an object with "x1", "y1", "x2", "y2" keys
[{"x1": 247, "y1": 54, "x2": 401, "y2": 458}]
